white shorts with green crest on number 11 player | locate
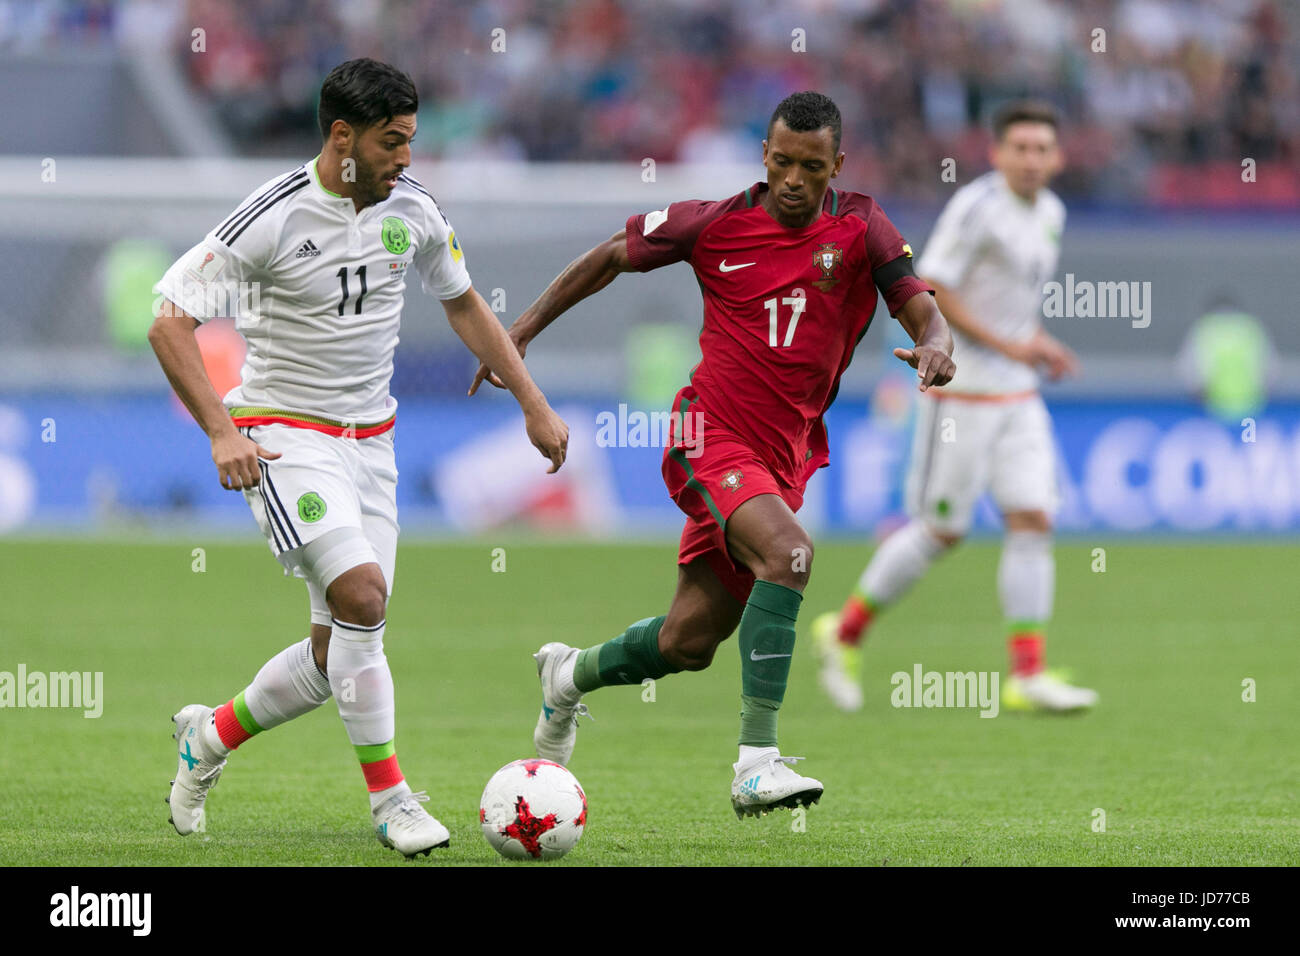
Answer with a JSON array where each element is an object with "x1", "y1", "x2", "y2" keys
[{"x1": 239, "y1": 424, "x2": 398, "y2": 624}]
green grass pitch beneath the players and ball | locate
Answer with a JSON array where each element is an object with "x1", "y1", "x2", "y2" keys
[{"x1": 0, "y1": 540, "x2": 1300, "y2": 866}]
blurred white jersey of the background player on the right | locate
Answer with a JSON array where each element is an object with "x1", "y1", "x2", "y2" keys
[{"x1": 917, "y1": 170, "x2": 1065, "y2": 394}]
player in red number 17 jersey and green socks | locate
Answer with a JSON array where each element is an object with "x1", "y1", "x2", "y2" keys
[{"x1": 471, "y1": 92, "x2": 956, "y2": 817}]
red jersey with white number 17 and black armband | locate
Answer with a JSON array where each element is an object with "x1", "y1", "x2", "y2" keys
[{"x1": 627, "y1": 182, "x2": 933, "y2": 486}]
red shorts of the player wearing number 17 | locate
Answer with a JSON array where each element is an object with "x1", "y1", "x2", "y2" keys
[{"x1": 663, "y1": 386, "x2": 806, "y2": 604}]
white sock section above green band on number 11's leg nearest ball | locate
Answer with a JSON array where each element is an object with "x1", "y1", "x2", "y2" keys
[{"x1": 329, "y1": 620, "x2": 394, "y2": 747}]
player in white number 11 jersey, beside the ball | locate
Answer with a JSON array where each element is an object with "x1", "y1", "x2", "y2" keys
[{"x1": 150, "y1": 59, "x2": 568, "y2": 857}]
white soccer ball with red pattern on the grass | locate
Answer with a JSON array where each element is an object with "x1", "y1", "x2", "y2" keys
[{"x1": 478, "y1": 758, "x2": 586, "y2": 860}]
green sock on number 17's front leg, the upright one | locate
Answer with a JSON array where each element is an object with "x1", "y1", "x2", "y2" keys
[{"x1": 740, "y1": 580, "x2": 803, "y2": 747}]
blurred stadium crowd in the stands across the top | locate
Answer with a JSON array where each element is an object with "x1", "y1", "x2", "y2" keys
[{"x1": 0, "y1": 0, "x2": 1300, "y2": 204}]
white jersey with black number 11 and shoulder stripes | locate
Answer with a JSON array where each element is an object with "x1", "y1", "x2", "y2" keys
[{"x1": 153, "y1": 157, "x2": 471, "y2": 425}]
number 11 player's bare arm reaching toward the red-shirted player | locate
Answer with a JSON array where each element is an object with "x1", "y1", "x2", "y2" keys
[{"x1": 442, "y1": 286, "x2": 568, "y2": 475}]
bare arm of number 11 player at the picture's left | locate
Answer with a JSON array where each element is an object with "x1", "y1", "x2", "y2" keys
[{"x1": 150, "y1": 299, "x2": 280, "y2": 492}]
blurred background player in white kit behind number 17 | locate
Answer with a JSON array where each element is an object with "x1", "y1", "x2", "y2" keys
[{"x1": 813, "y1": 100, "x2": 1097, "y2": 711}]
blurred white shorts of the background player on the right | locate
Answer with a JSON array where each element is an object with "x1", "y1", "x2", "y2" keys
[{"x1": 906, "y1": 393, "x2": 1058, "y2": 535}]
